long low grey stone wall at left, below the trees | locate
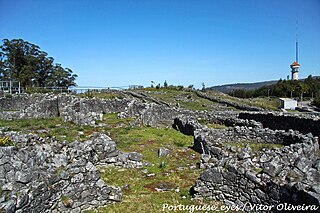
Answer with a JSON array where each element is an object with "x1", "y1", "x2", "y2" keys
[{"x1": 0, "y1": 94, "x2": 130, "y2": 125}]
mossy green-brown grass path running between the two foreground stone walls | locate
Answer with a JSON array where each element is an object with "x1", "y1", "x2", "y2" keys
[{"x1": 98, "y1": 127, "x2": 222, "y2": 212}]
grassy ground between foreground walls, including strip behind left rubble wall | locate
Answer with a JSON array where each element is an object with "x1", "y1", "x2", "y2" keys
[{"x1": 0, "y1": 114, "x2": 221, "y2": 212}]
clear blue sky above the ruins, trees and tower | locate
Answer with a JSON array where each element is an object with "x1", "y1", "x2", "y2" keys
[{"x1": 0, "y1": 0, "x2": 320, "y2": 88}]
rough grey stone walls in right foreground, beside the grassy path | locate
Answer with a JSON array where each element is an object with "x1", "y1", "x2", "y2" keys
[{"x1": 174, "y1": 117, "x2": 320, "y2": 206}]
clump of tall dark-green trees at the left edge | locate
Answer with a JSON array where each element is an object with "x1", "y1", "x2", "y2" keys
[{"x1": 0, "y1": 39, "x2": 78, "y2": 88}]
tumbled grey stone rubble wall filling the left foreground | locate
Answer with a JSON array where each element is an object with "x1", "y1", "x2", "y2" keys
[{"x1": 0, "y1": 132, "x2": 143, "y2": 212}]
